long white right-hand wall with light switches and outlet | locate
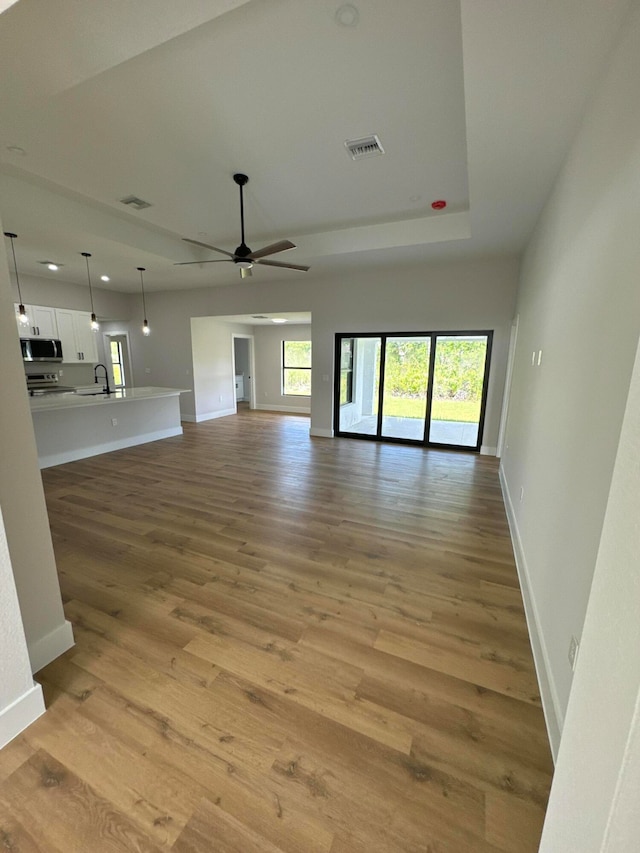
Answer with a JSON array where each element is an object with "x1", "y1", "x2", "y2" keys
[{"x1": 502, "y1": 4, "x2": 640, "y2": 756}]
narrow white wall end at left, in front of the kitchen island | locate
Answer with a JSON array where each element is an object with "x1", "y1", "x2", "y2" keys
[{"x1": 0, "y1": 226, "x2": 73, "y2": 671}]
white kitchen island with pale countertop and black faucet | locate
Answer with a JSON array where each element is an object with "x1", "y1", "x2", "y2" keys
[{"x1": 29, "y1": 387, "x2": 188, "y2": 468}]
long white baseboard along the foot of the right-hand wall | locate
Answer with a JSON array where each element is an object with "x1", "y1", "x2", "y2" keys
[{"x1": 499, "y1": 465, "x2": 564, "y2": 762}]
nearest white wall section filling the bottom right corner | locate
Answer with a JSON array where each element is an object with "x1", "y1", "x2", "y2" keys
[{"x1": 540, "y1": 332, "x2": 640, "y2": 853}]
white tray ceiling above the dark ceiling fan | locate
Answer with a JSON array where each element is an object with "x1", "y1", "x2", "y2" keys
[{"x1": 0, "y1": 0, "x2": 629, "y2": 291}]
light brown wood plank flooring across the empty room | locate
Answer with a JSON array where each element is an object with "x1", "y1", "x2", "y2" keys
[{"x1": 0, "y1": 412, "x2": 552, "y2": 853}]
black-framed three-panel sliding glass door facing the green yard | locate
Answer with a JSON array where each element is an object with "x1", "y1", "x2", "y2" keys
[{"x1": 334, "y1": 331, "x2": 492, "y2": 450}]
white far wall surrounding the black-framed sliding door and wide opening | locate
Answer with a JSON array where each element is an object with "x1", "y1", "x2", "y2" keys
[{"x1": 131, "y1": 258, "x2": 518, "y2": 448}]
